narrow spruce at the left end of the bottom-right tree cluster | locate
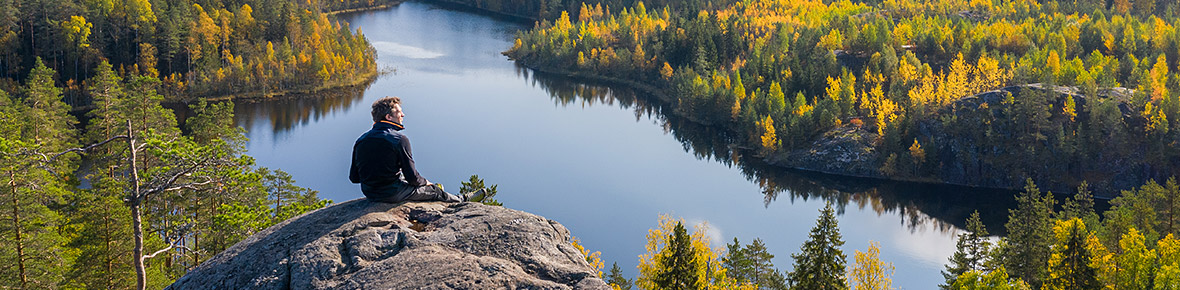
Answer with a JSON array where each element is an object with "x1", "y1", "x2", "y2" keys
[{"x1": 938, "y1": 211, "x2": 991, "y2": 289}]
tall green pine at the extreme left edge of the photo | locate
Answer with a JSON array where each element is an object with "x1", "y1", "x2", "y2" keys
[{"x1": 0, "y1": 66, "x2": 77, "y2": 289}]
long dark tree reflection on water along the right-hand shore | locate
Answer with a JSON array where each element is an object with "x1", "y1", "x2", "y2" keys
[{"x1": 517, "y1": 66, "x2": 1017, "y2": 236}]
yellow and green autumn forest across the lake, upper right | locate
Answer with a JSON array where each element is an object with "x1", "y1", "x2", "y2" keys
[{"x1": 505, "y1": 0, "x2": 1180, "y2": 197}]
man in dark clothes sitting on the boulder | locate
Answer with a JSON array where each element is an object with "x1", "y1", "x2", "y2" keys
[{"x1": 348, "y1": 97, "x2": 483, "y2": 203}]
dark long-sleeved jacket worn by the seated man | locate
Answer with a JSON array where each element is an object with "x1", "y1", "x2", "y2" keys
[{"x1": 348, "y1": 120, "x2": 426, "y2": 189}]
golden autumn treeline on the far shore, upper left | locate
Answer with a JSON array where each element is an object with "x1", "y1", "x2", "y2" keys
[{"x1": 0, "y1": 0, "x2": 377, "y2": 106}]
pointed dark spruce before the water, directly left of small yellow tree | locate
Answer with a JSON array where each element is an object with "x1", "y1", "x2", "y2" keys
[{"x1": 787, "y1": 203, "x2": 848, "y2": 289}]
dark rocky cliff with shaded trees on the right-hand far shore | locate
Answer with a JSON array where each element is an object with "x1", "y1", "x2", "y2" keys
[{"x1": 766, "y1": 84, "x2": 1142, "y2": 197}]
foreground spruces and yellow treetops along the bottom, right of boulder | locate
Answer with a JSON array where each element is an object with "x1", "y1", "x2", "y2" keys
[{"x1": 599, "y1": 175, "x2": 1180, "y2": 290}]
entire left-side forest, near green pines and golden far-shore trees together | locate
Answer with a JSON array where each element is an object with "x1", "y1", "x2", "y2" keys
[{"x1": 0, "y1": 0, "x2": 394, "y2": 289}]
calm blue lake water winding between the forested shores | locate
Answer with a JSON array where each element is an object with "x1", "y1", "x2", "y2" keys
[{"x1": 230, "y1": 2, "x2": 1012, "y2": 289}]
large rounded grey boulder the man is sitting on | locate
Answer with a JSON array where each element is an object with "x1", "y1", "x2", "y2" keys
[{"x1": 168, "y1": 198, "x2": 610, "y2": 289}]
